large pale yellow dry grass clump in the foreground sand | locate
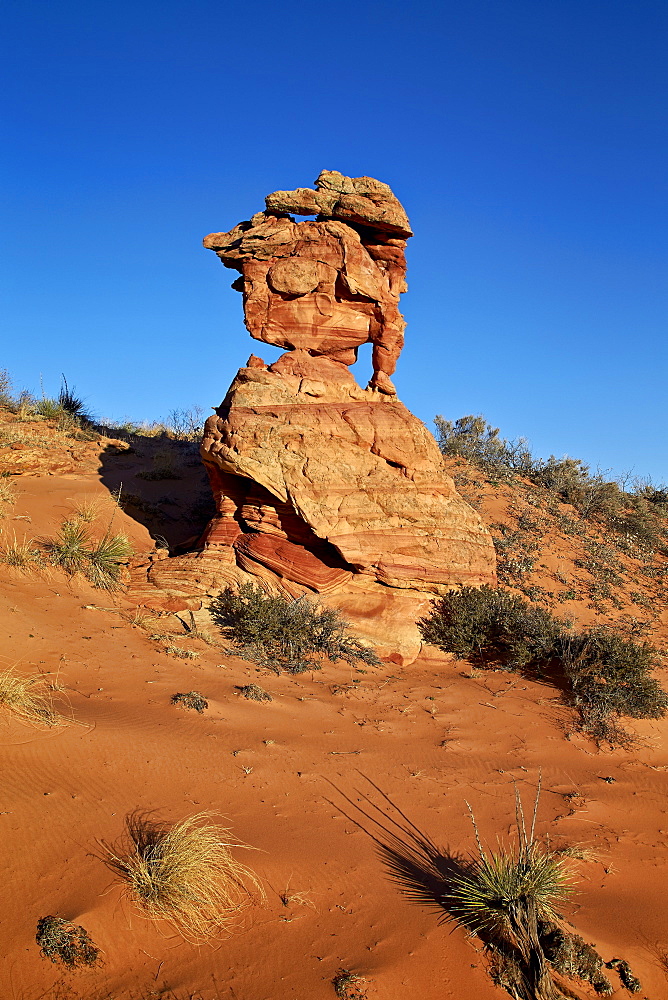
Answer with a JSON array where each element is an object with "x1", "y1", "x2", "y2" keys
[{"x1": 101, "y1": 812, "x2": 264, "y2": 942}]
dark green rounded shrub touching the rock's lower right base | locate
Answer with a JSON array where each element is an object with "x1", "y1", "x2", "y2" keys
[{"x1": 418, "y1": 586, "x2": 565, "y2": 669}]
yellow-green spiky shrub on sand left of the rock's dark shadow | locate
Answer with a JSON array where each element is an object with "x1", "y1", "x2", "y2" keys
[{"x1": 44, "y1": 515, "x2": 132, "y2": 590}]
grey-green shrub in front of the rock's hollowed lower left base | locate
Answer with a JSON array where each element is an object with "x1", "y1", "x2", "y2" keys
[{"x1": 210, "y1": 583, "x2": 380, "y2": 674}]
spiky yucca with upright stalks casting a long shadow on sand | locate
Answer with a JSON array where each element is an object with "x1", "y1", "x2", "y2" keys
[{"x1": 448, "y1": 782, "x2": 572, "y2": 1000}]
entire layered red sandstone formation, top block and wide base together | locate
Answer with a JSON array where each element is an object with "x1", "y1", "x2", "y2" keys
[{"x1": 132, "y1": 171, "x2": 495, "y2": 662}]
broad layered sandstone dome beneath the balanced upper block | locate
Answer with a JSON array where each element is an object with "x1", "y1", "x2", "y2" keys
[{"x1": 201, "y1": 360, "x2": 495, "y2": 594}]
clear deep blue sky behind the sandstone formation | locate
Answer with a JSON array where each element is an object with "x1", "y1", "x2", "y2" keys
[{"x1": 0, "y1": 0, "x2": 668, "y2": 481}]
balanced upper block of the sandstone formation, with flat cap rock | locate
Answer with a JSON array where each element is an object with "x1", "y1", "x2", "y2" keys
[{"x1": 204, "y1": 170, "x2": 411, "y2": 395}]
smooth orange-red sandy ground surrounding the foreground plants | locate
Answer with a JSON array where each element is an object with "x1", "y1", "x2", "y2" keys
[{"x1": 0, "y1": 434, "x2": 668, "y2": 1000}]
